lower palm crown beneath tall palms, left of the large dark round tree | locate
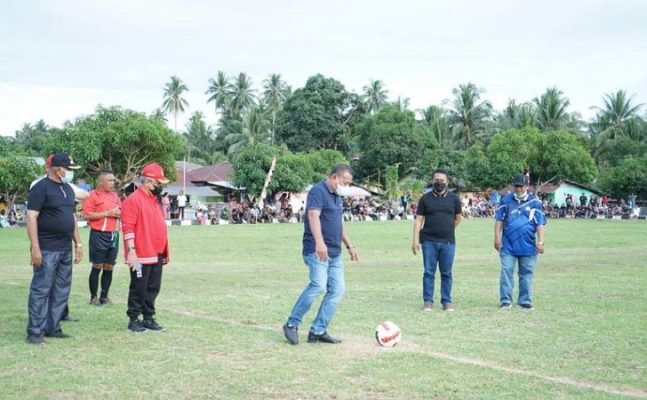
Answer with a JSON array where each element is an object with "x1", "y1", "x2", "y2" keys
[{"x1": 223, "y1": 106, "x2": 270, "y2": 158}]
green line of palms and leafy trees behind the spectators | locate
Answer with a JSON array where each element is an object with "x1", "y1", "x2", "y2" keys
[{"x1": 0, "y1": 71, "x2": 647, "y2": 211}]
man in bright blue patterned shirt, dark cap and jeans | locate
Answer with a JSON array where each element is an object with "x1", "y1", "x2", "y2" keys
[{"x1": 494, "y1": 174, "x2": 546, "y2": 310}]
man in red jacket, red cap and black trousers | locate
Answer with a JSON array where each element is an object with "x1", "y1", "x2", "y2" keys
[{"x1": 121, "y1": 163, "x2": 169, "y2": 333}]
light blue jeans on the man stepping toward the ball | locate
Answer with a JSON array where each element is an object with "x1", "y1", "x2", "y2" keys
[{"x1": 288, "y1": 253, "x2": 346, "y2": 335}]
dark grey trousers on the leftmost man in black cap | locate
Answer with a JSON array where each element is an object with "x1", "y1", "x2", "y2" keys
[{"x1": 27, "y1": 250, "x2": 72, "y2": 335}]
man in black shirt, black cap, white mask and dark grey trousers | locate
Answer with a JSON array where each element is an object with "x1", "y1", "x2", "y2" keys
[{"x1": 27, "y1": 153, "x2": 83, "y2": 344}]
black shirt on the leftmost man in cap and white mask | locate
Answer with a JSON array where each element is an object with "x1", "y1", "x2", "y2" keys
[{"x1": 27, "y1": 178, "x2": 76, "y2": 251}]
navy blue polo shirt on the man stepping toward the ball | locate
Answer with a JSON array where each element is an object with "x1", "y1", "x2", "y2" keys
[{"x1": 303, "y1": 179, "x2": 344, "y2": 257}]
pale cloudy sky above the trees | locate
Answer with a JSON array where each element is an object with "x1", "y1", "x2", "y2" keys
[{"x1": 0, "y1": 0, "x2": 647, "y2": 135}]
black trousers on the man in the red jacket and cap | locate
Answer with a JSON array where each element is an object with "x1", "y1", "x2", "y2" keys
[{"x1": 126, "y1": 255, "x2": 164, "y2": 320}]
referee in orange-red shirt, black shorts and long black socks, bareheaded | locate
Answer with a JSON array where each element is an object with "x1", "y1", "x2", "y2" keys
[{"x1": 83, "y1": 170, "x2": 121, "y2": 306}]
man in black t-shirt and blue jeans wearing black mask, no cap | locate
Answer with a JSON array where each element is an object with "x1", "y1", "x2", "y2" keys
[{"x1": 411, "y1": 168, "x2": 462, "y2": 311}]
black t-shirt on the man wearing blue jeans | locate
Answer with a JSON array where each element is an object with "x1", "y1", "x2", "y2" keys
[{"x1": 416, "y1": 191, "x2": 462, "y2": 243}]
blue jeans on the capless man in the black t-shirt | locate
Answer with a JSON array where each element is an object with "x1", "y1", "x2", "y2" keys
[{"x1": 421, "y1": 240, "x2": 456, "y2": 304}]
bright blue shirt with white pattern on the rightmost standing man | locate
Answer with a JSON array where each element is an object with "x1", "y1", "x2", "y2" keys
[{"x1": 495, "y1": 193, "x2": 546, "y2": 256}]
